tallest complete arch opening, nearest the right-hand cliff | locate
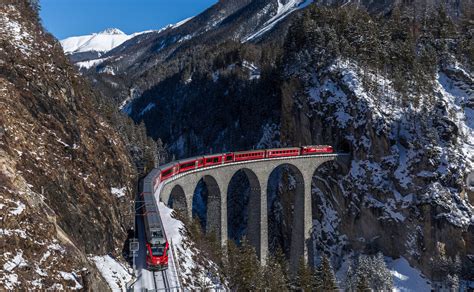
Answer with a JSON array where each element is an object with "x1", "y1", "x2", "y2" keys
[{"x1": 267, "y1": 164, "x2": 305, "y2": 267}]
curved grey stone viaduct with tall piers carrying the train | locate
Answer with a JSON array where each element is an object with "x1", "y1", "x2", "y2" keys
[{"x1": 155, "y1": 154, "x2": 345, "y2": 267}]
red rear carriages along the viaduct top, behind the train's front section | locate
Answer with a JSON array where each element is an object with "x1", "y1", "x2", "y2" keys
[{"x1": 155, "y1": 145, "x2": 334, "y2": 186}]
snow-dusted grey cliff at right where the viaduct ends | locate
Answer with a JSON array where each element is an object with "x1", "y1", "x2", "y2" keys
[{"x1": 281, "y1": 9, "x2": 474, "y2": 281}]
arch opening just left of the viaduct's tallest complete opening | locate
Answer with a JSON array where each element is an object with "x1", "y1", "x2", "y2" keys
[{"x1": 227, "y1": 168, "x2": 261, "y2": 250}]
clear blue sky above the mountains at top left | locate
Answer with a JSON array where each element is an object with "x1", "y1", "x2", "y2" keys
[{"x1": 40, "y1": 0, "x2": 217, "y2": 39}]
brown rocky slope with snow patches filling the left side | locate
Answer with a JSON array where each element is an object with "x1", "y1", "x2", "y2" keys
[{"x1": 0, "y1": 1, "x2": 135, "y2": 291}]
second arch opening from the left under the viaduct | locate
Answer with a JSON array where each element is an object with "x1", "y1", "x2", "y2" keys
[{"x1": 192, "y1": 175, "x2": 222, "y2": 238}]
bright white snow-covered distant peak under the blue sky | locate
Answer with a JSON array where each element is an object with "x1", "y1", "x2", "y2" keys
[{"x1": 61, "y1": 28, "x2": 141, "y2": 54}]
